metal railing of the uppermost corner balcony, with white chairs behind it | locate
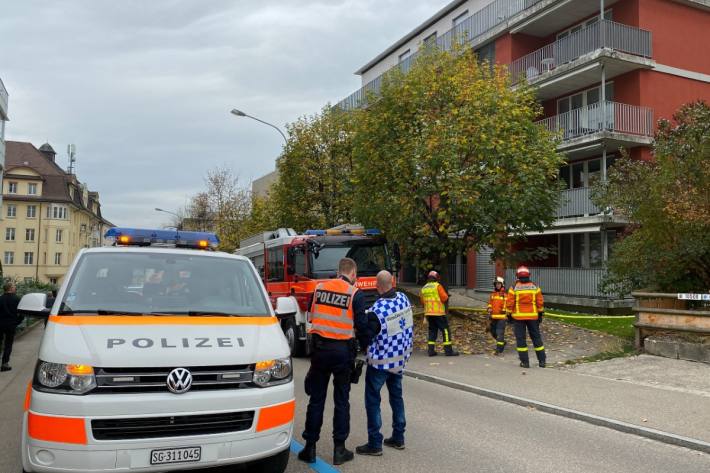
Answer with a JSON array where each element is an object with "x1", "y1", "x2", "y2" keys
[{"x1": 510, "y1": 20, "x2": 652, "y2": 83}]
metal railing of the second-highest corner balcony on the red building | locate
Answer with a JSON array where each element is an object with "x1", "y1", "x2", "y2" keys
[{"x1": 537, "y1": 102, "x2": 653, "y2": 140}]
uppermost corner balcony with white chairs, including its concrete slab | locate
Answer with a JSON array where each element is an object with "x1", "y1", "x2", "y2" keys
[{"x1": 509, "y1": 20, "x2": 653, "y2": 99}]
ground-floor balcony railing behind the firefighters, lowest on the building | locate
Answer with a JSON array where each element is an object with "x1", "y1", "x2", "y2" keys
[{"x1": 505, "y1": 268, "x2": 612, "y2": 298}]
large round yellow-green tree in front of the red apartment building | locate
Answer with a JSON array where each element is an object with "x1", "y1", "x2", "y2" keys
[{"x1": 353, "y1": 48, "x2": 563, "y2": 272}]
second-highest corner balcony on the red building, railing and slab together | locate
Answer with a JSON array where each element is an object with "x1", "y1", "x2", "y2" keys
[{"x1": 537, "y1": 101, "x2": 654, "y2": 152}]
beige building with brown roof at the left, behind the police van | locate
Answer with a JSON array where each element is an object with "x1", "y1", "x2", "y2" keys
[{"x1": 0, "y1": 141, "x2": 112, "y2": 284}]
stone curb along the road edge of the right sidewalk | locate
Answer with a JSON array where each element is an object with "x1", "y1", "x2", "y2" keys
[{"x1": 404, "y1": 371, "x2": 710, "y2": 453}]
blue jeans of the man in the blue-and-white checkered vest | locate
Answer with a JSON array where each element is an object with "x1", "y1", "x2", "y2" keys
[{"x1": 365, "y1": 366, "x2": 407, "y2": 448}]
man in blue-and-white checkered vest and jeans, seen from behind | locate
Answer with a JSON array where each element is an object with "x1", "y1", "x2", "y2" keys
[{"x1": 355, "y1": 271, "x2": 414, "y2": 456}]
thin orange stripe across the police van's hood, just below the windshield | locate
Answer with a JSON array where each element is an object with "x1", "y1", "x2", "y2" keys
[{"x1": 49, "y1": 315, "x2": 278, "y2": 325}]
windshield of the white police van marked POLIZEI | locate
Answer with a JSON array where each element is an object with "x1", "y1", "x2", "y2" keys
[{"x1": 59, "y1": 252, "x2": 271, "y2": 316}]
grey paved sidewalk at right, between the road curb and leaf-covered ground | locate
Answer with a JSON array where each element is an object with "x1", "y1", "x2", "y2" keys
[{"x1": 407, "y1": 352, "x2": 710, "y2": 442}]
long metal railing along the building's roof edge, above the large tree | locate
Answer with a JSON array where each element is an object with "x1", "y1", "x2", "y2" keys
[{"x1": 338, "y1": 0, "x2": 542, "y2": 110}]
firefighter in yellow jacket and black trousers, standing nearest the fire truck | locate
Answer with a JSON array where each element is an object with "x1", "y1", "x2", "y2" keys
[{"x1": 419, "y1": 271, "x2": 459, "y2": 356}]
